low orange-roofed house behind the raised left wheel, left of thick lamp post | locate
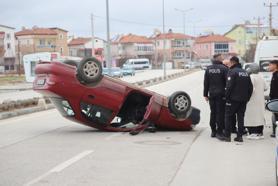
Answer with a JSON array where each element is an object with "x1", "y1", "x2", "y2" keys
[{"x1": 68, "y1": 37, "x2": 106, "y2": 61}]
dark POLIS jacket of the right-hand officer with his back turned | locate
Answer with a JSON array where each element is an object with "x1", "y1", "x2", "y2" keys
[{"x1": 226, "y1": 64, "x2": 253, "y2": 102}]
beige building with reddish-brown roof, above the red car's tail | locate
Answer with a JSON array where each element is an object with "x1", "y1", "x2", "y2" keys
[{"x1": 15, "y1": 27, "x2": 68, "y2": 59}]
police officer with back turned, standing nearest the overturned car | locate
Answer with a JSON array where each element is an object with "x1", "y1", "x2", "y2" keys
[{"x1": 204, "y1": 54, "x2": 228, "y2": 138}]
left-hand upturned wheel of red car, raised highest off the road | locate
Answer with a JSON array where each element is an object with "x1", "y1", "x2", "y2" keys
[{"x1": 77, "y1": 57, "x2": 103, "y2": 83}]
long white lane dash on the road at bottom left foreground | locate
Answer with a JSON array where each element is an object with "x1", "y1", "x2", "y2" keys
[{"x1": 24, "y1": 150, "x2": 94, "y2": 186}]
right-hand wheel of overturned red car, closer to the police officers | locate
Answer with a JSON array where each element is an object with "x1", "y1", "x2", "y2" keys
[{"x1": 168, "y1": 91, "x2": 191, "y2": 119}]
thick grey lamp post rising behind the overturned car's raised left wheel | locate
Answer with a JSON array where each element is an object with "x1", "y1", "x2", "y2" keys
[{"x1": 106, "y1": 0, "x2": 112, "y2": 75}]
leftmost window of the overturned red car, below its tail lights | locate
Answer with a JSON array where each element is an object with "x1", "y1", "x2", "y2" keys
[{"x1": 51, "y1": 98, "x2": 75, "y2": 117}]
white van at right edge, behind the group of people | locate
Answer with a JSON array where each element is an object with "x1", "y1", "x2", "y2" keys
[{"x1": 255, "y1": 36, "x2": 278, "y2": 83}]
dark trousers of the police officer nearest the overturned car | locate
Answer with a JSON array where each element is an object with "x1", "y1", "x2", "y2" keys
[{"x1": 209, "y1": 97, "x2": 225, "y2": 134}]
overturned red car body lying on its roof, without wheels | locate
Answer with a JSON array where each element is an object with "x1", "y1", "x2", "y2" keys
[{"x1": 33, "y1": 62, "x2": 200, "y2": 131}]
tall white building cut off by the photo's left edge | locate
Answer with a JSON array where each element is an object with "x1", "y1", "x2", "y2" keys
[{"x1": 0, "y1": 25, "x2": 17, "y2": 73}]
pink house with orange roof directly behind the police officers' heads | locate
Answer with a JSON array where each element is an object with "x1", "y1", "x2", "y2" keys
[{"x1": 194, "y1": 34, "x2": 236, "y2": 59}]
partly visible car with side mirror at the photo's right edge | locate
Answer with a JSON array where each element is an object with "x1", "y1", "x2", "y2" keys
[{"x1": 266, "y1": 99, "x2": 278, "y2": 186}]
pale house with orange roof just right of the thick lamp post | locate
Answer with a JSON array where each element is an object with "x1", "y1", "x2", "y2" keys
[{"x1": 111, "y1": 34, "x2": 154, "y2": 66}]
